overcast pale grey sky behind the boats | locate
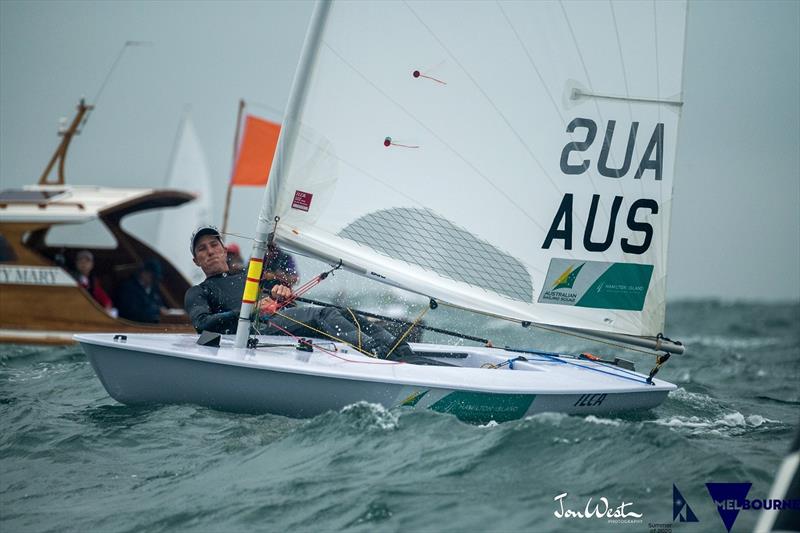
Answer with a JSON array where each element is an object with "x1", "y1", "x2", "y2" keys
[{"x1": 0, "y1": 0, "x2": 800, "y2": 300}]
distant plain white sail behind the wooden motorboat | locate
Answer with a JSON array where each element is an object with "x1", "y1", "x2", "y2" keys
[{"x1": 156, "y1": 113, "x2": 211, "y2": 283}]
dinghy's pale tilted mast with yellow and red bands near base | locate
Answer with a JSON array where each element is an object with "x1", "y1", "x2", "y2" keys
[{"x1": 236, "y1": 0, "x2": 331, "y2": 348}]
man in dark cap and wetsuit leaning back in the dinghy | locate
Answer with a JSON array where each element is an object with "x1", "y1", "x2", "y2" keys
[{"x1": 184, "y1": 226, "x2": 414, "y2": 360}]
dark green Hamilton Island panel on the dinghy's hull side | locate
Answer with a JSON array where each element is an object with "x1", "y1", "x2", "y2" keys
[{"x1": 430, "y1": 391, "x2": 536, "y2": 424}]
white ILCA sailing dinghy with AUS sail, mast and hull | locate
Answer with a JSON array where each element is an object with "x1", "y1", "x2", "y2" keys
[{"x1": 76, "y1": 1, "x2": 687, "y2": 423}]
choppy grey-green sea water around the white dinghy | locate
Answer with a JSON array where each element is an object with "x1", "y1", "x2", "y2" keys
[{"x1": 0, "y1": 302, "x2": 800, "y2": 532}]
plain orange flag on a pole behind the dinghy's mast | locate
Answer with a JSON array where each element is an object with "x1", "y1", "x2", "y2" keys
[{"x1": 231, "y1": 115, "x2": 281, "y2": 186}]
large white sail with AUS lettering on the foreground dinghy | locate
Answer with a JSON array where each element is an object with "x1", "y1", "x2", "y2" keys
[{"x1": 270, "y1": 1, "x2": 687, "y2": 336}]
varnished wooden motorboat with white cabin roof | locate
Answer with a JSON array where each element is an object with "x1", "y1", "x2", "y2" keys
[{"x1": 0, "y1": 101, "x2": 194, "y2": 344}]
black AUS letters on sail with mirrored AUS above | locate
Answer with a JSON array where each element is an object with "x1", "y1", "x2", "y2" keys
[{"x1": 542, "y1": 118, "x2": 664, "y2": 254}]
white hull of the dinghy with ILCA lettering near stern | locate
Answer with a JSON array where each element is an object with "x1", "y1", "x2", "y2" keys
[{"x1": 75, "y1": 334, "x2": 676, "y2": 423}]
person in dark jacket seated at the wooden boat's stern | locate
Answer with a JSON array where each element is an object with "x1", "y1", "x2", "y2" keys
[{"x1": 116, "y1": 259, "x2": 165, "y2": 323}]
